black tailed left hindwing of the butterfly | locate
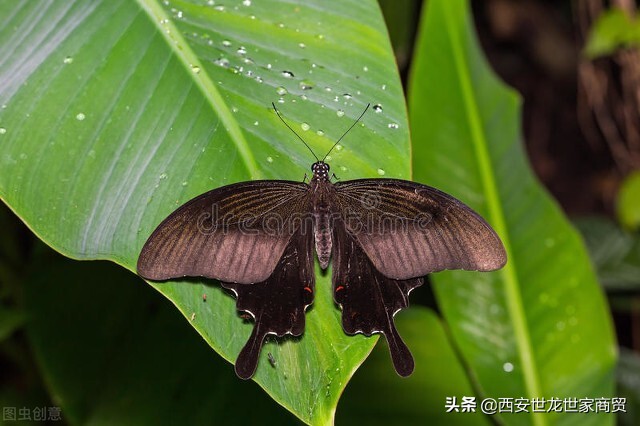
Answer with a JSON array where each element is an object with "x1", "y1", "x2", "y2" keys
[{"x1": 222, "y1": 221, "x2": 315, "y2": 379}]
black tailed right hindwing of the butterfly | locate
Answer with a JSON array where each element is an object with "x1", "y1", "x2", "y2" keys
[{"x1": 333, "y1": 220, "x2": 423, "y2": 377}]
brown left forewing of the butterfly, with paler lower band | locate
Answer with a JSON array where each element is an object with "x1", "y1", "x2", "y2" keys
[{"x1": 138, "y1": 181, "x2": 309, "y2": 284}]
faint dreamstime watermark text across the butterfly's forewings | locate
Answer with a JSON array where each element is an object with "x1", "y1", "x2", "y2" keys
[{"x1": 197, "y1": 201, "x2": 434, "y2": 236}]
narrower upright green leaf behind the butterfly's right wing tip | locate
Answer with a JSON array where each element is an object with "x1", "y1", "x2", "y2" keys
[{"x1": 409, "y1": 0, "x2": 616, "y2": 425}]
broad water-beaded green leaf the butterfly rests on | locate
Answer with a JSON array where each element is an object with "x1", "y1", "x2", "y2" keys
[{"x1": 0, "y1": 0, "x2": 409, "y2": 424}]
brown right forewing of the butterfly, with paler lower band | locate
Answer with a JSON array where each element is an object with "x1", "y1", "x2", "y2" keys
[{"x1": 335, "y1": 179, "x2": 507, "y2": 280}]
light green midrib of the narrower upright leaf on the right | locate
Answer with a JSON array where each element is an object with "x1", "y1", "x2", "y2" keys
[{"x1": 445, "y1": 7, "x2": 547, "y2": 425}]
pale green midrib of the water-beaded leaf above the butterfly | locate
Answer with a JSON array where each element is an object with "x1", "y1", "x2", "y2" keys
[{"x1": 137, "y1": 0, "x2": 263, "y2": 179}]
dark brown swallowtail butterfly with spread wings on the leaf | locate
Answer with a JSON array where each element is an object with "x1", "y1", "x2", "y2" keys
[{"x1": 138, "y1": 105, "x2": 506, "y2": 379}]
